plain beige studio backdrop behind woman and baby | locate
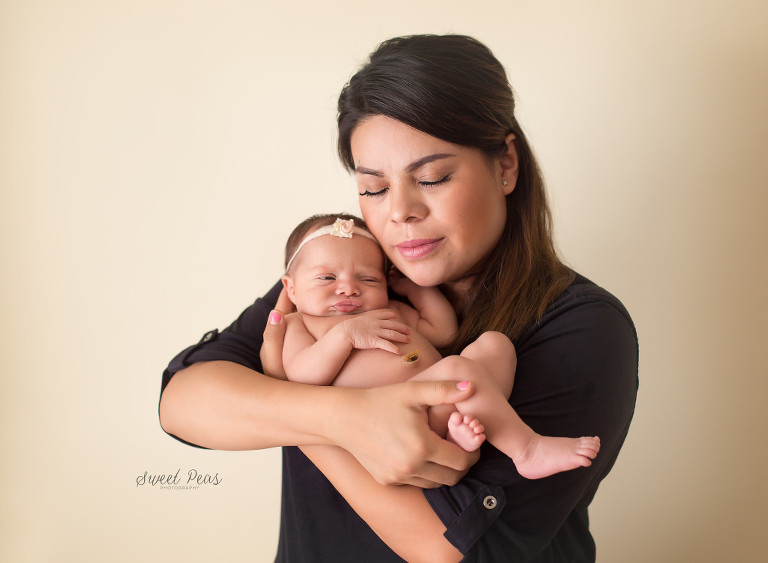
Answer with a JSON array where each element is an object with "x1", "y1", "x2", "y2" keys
[{"x1": 0, "y1": 0, "x2": 768, "y2": 563}]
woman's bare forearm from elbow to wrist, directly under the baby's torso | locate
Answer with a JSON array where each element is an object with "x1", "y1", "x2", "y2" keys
[{"x1": 160, "y1": 361, "x2": 340, "y2": 450}]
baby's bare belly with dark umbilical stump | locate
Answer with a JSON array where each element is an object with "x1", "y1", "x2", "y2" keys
[{"x1": 333, "y1": 332, "x2": 440, "y2": 387}]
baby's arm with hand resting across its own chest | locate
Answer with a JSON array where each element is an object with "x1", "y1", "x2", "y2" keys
[{"x1": 283, "y1": 309, "x2": 408, "y2": 385}]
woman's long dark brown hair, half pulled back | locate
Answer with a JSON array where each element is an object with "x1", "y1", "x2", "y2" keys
[{"x1": 338, "y1": 35, "x2": 574, "y2": 352}]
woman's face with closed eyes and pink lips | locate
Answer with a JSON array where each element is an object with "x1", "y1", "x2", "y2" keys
[{"x1": 351, "y1": 115, "x2": 517, "y2": 290}]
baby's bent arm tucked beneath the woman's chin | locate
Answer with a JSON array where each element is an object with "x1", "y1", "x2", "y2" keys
[{"x1": 390, "y1": 277, "x2": 459, "y2": 348}]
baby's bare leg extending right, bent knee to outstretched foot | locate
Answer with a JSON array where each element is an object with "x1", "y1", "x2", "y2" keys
[{"x1": 422, "y1": 332, "x2": 600, "y2": 479}]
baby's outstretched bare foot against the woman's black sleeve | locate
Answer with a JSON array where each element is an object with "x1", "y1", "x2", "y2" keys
[{"x1": 513, "y1": 434, "x2": 600, "y2": 479}]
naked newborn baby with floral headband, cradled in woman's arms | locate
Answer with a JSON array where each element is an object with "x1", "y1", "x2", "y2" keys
[{"x1": 283, "y1": 219, "x2": 600, "y2": 479}]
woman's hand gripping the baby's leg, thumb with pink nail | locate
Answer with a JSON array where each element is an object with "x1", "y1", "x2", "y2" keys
[{"x1": 329, "y1": 381, "x2": 479, "y2": 488}]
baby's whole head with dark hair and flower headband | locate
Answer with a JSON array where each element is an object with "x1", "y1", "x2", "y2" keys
[{"x1": 283, "y1": 213, "x2": 388, "y2": 317}]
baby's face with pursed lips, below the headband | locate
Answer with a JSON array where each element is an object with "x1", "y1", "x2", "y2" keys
[{"x1": 283, "y1": 236, "x2": 389, "y2": 317}]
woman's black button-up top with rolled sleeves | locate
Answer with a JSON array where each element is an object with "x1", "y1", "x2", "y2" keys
[{"x1": 163, "y1": 275, "x2": 638, "y2": 563}]
